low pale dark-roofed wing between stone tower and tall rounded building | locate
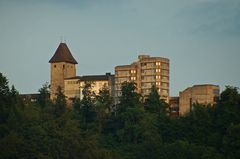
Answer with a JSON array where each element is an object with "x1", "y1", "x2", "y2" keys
[{"x1": 64, "y1": 73, "x2": 114, "y2": 101}]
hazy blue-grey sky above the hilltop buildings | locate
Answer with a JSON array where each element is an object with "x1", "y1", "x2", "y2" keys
[{"x1": 0, "y1": 0, "x2": 240, "y2": 96}]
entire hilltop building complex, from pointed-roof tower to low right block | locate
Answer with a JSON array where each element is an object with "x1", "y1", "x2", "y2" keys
[{"x1": 49, "y1": 42, "x2": 220, "y2": 115}]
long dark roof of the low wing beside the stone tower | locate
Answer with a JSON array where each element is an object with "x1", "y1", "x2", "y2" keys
[{"x1": 65, "y1": 74, "x2": 114, "y2": 81}]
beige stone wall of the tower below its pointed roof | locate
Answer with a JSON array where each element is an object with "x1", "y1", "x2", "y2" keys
[{"x1": 50, "y1": 62, "x2": 76, "y2": 99}]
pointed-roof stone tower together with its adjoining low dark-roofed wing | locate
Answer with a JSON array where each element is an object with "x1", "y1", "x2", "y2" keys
[{"x1": 49, "y1": 43, "x2": 114, "y2": 102}]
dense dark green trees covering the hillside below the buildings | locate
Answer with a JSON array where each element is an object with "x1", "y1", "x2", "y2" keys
[{"x1": 0, "y1": 73, "x2": 240, "y2": 159}]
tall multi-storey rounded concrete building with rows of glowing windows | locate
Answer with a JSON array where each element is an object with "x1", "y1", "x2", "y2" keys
[{"x1": 115, "y1": 55, "x2": 169, "y2": 102}]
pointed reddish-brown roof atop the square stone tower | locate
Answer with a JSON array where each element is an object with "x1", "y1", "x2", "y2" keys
[{"x1": 49, "y1": 43, "x2": 77, "y2": 64}]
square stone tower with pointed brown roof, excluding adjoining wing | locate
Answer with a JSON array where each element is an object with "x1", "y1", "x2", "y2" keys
[{"x1": 49, "y1": 43, "x2": 77, "y2": 99}]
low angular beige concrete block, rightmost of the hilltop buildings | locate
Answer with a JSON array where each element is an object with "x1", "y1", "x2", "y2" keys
[{"x1": 179, "y1": 84, "x2": 220, "y2": 115}]
